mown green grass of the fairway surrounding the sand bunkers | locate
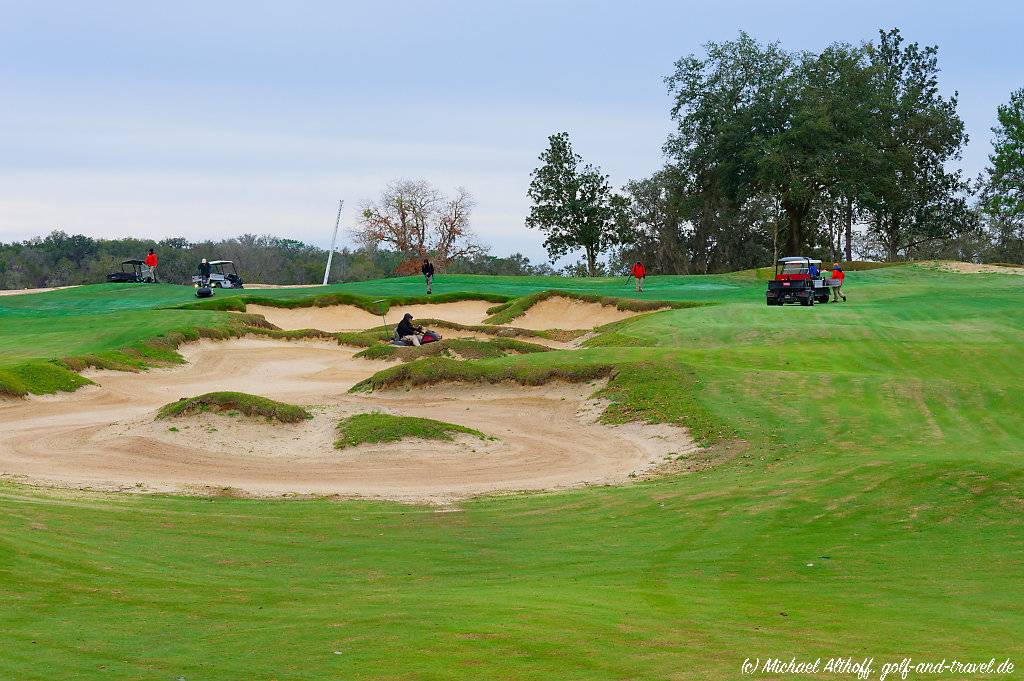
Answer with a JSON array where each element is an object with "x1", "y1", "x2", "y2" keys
[{"x1": 0, "y1": 266, "x2": 1024, "y2": 681}]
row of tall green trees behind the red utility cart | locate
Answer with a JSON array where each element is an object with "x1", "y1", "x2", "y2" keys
[{"x1": 526, "y1": 29, "x2": 1024, "y2": 275}]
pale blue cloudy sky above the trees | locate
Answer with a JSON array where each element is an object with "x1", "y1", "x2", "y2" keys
[{"x1": 0, "y1": 0, "x2": 1024, "y2": 262}]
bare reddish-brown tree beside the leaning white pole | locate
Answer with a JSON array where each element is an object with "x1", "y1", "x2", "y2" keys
[{"x1": 353, "y1": 180, "x2": 482, "y2": 266}]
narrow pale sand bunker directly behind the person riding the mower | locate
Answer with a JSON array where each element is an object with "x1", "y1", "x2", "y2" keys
[{"x1": 246, "y1": 300, "x2": 494, "y2": 333}]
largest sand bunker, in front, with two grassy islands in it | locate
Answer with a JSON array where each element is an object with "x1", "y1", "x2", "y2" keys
[{"x1": 0, "y1": 338, "x2": 693, "y2": 502}]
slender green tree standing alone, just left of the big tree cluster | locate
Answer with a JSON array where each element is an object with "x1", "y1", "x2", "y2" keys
[{"x1": 526, "y1": 132, "x2": 627, "y2": 276}]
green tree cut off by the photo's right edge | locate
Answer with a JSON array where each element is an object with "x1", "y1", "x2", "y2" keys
[{"x1": 979, "y1": 88, "x2": 1024, "y2": 262}]
